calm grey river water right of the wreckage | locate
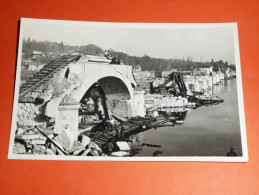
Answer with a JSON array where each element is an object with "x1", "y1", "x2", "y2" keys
[{"x1": 132, "y1": 79, "x2": 242, "y2": 156}]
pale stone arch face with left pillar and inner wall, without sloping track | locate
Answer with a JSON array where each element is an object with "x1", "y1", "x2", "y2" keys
[{"x1": 57, "y1": 63, "x2": 139, "y2": 134}]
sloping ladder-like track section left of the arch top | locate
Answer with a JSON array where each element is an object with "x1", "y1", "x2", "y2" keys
[{"x1": 19, "y1": 54, "x2": 81, "y2": 96}]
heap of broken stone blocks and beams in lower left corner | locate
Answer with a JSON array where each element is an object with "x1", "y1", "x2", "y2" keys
[{"x1": 13, "y1": 126, "x2": 106, "y2": 156}]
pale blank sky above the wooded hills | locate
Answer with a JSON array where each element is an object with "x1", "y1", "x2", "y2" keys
[{"x1": 21, "y1": 19, "x2": 239, "y2": 64}]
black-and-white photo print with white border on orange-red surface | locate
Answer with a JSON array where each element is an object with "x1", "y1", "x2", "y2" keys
[{"x1": 8, "y1": 18, "x2": 248, "y2": 162}]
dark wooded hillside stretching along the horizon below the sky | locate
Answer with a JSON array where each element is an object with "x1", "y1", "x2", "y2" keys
[{"x1": 22, "y1": 38, "x2": 234, "y2": 71}]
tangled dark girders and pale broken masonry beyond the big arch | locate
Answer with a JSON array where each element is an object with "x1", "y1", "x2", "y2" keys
[{"x1": 145, "y1": 72, "x2": 224, "y2": 111}]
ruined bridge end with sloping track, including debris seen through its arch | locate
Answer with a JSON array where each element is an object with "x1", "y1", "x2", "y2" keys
[{"x1": 17, "y1": 52, "x2": 145, "y2": 157}]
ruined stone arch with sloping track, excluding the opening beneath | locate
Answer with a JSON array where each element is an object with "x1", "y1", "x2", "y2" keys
[{"x1": 18, "y1": 52, "x2": 144, "y2": 139}]
